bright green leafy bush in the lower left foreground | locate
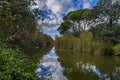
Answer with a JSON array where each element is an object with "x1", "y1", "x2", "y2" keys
[{"x1": 0, "y1": 48, "x2": 38, "y2": 80}]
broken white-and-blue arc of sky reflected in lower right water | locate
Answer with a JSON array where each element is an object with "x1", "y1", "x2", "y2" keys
[{"x1": 67, "y1": 62, "x2": 110, "y2": 80}]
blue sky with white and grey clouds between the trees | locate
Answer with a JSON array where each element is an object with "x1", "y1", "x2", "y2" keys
[{"x1": 36, "y1": 0, "x2": 98, "y2": 39}]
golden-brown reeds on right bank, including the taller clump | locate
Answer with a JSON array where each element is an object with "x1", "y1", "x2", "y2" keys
[{"x1": 55, "y1": 31, "x2": 92, "y2": 52}]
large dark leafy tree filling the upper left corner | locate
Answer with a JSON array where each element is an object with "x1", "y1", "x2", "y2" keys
[{"x1": 0, "y1": 0, "x2": 40, "y2": 48}]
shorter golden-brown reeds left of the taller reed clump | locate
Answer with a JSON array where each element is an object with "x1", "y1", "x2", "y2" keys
[{"x1": 55, "y1": 36, "x2": 80, "y2": 50}]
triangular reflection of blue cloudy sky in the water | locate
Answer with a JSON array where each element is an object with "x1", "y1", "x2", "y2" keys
[{"x1": 36, "y1": 48, "x2": 67, "y2": 80}]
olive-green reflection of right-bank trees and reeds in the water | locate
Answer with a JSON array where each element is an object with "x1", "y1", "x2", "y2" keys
[{"x1": 57, "y1": 51, "x2": 120, "y2": 80}]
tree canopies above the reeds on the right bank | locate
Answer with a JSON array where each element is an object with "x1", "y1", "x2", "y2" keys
[{"x1": 58, "y1": 0, "x2": 120, "y2": 44}]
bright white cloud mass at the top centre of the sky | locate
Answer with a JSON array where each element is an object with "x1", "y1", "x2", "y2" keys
[{"x1": 37, "y1": 0, "x2": 73, "y2": 28}]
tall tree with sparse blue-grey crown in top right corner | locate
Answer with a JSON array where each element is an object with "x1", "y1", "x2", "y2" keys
[{"x1": 94, "y1": 0, "x2": 120, "y2": 28}]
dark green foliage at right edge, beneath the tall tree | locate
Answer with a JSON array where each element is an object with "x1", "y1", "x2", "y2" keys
[{"x1": 90, "y1": 24, "x2": 120, "y2": 44}]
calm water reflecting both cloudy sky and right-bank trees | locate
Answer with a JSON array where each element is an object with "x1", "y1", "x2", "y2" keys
[{"x1": 35, "y1": 48, "x2": 120, "y2": 80}]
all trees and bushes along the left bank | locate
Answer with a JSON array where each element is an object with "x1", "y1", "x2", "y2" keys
[{"x1": 0, "y1": 0, "x2": 53, "y2": 80}]
